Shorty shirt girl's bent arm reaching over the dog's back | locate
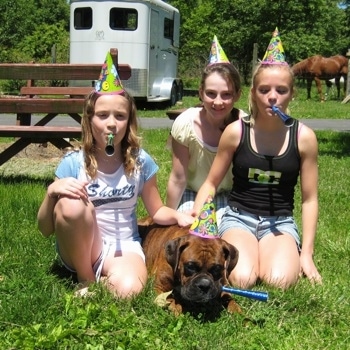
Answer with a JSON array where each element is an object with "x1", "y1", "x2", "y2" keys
[{"x1": 141, "y1": 175, "x2": 194, "y2": 227}]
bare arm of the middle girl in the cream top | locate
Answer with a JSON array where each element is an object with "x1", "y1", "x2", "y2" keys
[{"x1": 166, "y1": 137, "x2": 190, "y2": 209}]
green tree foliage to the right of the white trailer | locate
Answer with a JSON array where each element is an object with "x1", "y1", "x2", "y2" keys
[{"x1": 169, "y1": 0, "x2": 350, "y2": 81}]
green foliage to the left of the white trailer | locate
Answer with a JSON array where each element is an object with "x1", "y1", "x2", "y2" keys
[{"x1": 0, "y1": 0, "x2": 69, "y2": 62}]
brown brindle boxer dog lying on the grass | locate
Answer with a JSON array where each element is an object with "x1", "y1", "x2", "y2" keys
[{"x1": 138, "y1": 218, "x2": 241, "y2": 318}]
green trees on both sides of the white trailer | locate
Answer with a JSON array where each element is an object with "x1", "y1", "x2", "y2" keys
[{"x1": 0, "y1": 0, "x2": 350, "y2": 81}]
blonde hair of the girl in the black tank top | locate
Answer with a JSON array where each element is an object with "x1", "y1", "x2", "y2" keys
[{"x1": 244, "y1": 63, "x2": 295, "y2": 125}]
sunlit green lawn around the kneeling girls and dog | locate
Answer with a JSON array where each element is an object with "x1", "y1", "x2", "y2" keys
[{"x1": 0, "y1": 126, "x2": 350, "y2": 350}]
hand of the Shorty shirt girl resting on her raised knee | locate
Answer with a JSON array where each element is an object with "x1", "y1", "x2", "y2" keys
[{"x1": 47, "y1": 177, "x2": 89, "y2": 200}]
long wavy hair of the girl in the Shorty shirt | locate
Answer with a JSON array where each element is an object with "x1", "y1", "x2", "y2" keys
[{"x1": 81, "y1": 91, "x2": 141, "y2": 179}]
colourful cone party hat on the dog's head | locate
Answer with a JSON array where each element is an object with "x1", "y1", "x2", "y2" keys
[{"x1": 189, "y1": 195, "x2": 219, "y2": 238}]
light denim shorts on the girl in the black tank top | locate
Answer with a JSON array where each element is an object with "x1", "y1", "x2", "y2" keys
[{"x1": 219, "y1": 206, "x2": 300, "y2": 250}]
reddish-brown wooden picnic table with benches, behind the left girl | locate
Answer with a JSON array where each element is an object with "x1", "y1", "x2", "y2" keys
[{"x1": 0, "y1": 49, "x2": 131, "y2": 166}]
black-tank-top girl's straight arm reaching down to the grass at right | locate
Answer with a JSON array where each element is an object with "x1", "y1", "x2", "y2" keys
[{"x1": 298, "y1": 125, "x2": 322, "y2": 282}]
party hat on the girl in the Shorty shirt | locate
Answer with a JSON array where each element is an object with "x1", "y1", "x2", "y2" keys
[{"x1": 95, "y1": 52, "x2": 124, "y2": 94}]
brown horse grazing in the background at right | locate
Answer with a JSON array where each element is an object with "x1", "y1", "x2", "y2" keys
[{"x1": 292, "y1": 55, "x2": 348, "y2": 101}]
